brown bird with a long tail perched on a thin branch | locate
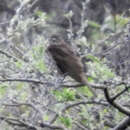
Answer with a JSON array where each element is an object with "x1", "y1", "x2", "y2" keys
[{"x1": 47, "y1": 35, "x2": 96, "y2": 95}]
